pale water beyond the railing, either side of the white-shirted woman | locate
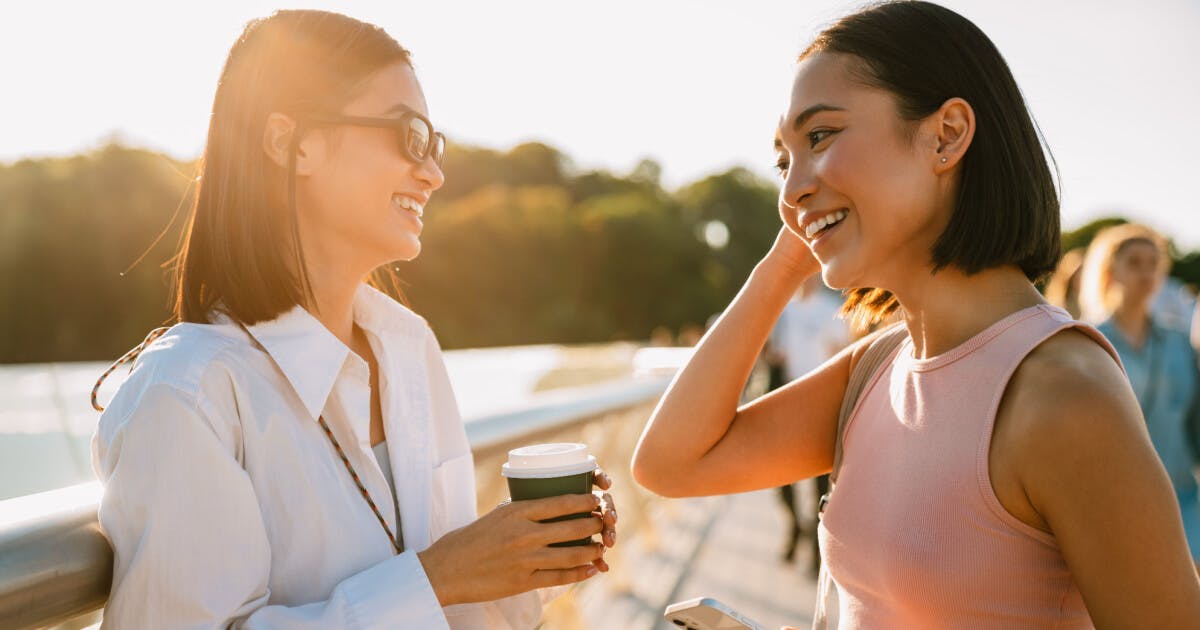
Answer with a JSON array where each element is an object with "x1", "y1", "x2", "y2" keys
[{"x1": 0, "y1": 344, "x2": 635, "y2": 500}]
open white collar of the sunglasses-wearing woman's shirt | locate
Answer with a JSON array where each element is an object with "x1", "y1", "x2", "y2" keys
[{"x1": 222, "y1": 284, "x2": 425, "y2": 419}]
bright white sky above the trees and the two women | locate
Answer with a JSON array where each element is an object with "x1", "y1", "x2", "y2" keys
[{"x1": 7, "y1": 0, "x2": 1200, "y2": 248}]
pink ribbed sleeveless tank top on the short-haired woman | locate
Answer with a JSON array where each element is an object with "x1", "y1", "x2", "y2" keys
[{"x1": 818, "y1": 305, "x2": 1121, "y2": 629}]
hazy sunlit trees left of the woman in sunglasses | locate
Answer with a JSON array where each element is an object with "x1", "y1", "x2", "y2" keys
[{"x1": 0, "y1": 145, "x2": 193, "y2": 364}]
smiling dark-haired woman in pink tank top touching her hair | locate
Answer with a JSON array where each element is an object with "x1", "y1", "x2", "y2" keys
[{"x1": 634, "y1": 2, "x2": 1200, "y2": 628}]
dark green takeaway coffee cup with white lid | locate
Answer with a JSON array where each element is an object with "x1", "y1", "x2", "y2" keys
[{"x1": 500, "y1": 443, "x2": 596, "y2": 547}]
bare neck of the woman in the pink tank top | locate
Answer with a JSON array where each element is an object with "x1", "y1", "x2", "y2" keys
[{"x1": 893, "y1": 266, "x2": 1045, "y2": 359}]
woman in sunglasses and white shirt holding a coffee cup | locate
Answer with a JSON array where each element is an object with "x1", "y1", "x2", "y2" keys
[{"x1": 94, "y1": 11, "x2": 616, "y2": 628}]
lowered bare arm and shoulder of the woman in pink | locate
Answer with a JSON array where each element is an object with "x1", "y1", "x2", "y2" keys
[{"x1": 1013, "y1": 332, "x2": 1200, "y2": 628}]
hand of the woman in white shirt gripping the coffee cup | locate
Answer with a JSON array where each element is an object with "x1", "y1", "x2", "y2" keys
[{"x1": 418, "y1": 470, "x2": 617, "y2": 606}]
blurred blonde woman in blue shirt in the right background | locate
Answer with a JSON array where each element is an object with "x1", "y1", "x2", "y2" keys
[{"x1": 1080, "y1": 223, "x2": 1200, "y2": 559}]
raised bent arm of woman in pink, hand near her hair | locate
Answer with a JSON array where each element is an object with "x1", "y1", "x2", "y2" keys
[{"x1": 634, "y1": 228, "x2": 859, "y2": 497}]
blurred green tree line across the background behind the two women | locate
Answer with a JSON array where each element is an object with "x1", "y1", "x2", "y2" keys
[{"x1": 0, "y1": 143, "x2": 1200, "y2": 364}]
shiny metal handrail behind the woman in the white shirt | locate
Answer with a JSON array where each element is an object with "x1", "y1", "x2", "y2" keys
[{"x1": 0, "y1": 377, "x2": 668, "y2": 629}]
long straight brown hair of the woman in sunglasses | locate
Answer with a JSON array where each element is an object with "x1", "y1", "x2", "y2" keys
[{"x1": 173, "y1": 11, "x2": 412, "y2": 324}]
